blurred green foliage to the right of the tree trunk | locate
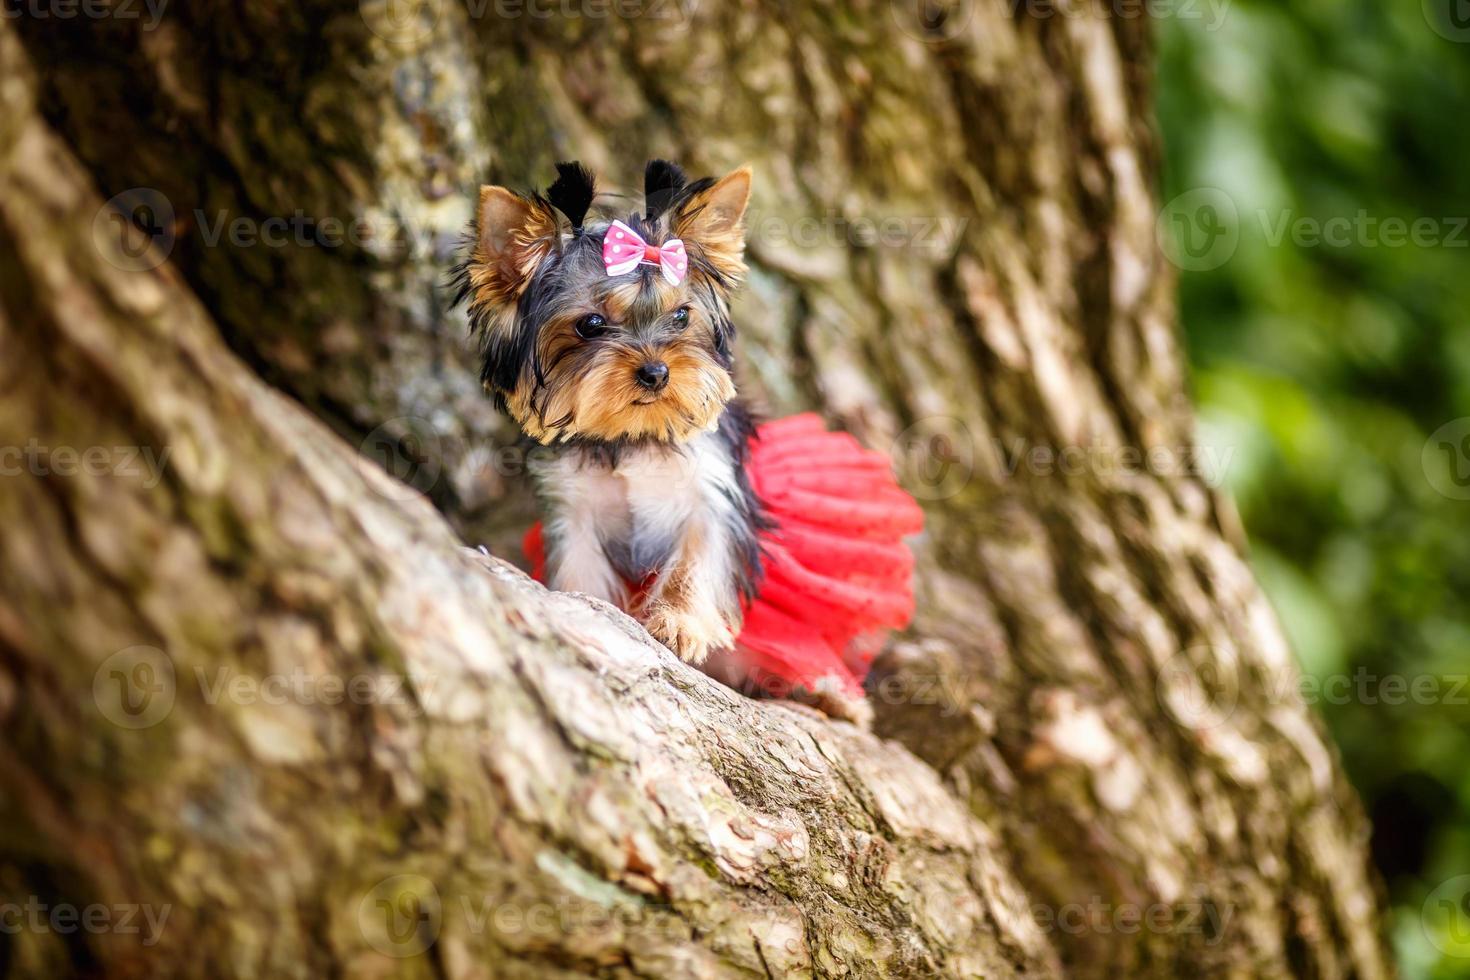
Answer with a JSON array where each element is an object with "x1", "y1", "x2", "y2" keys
[{"x1": 1157, "y1": 0, "x2": 1470, "y2": 979}]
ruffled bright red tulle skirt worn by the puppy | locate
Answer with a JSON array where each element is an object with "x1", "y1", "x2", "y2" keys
[{"x1": 522, "y1": 413, "x2": 923, "y2": 714}]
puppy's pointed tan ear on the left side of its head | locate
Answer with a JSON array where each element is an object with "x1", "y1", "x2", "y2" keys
[{"x1": 467, "y1": 185, "x2": 557, "y2": 314}]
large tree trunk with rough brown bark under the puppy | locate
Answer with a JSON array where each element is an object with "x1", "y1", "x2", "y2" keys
[{"x1": 0, "y1": 0, "x2": 1391, "y2": 977}]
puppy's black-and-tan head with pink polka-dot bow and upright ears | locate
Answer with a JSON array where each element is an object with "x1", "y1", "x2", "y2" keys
[{"x1": 457, "y1": 160, "x2": 750, "y2": 442}]
